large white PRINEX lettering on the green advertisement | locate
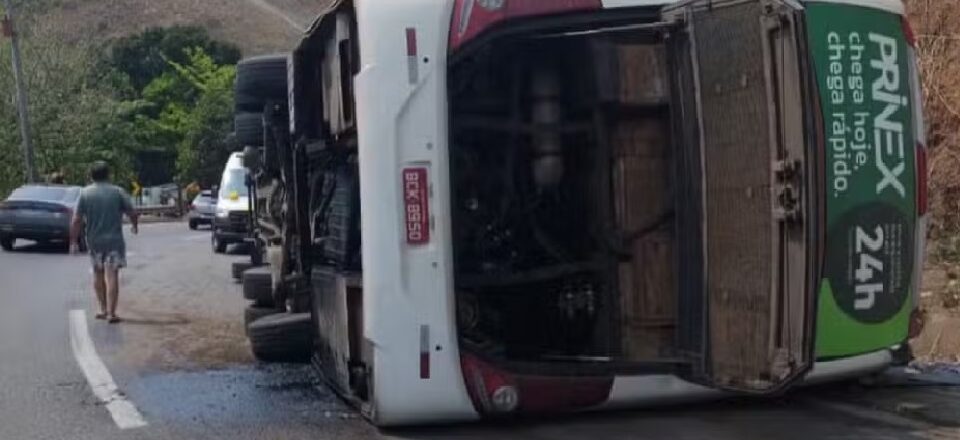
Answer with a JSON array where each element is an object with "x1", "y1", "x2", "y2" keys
[{"x1": 870, "y1": 33, "x2": 910, "y2": 197}]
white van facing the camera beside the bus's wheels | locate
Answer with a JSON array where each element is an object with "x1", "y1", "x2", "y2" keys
[{"x1": 211, "y1": 153, "x2": 250, "y2": 254}]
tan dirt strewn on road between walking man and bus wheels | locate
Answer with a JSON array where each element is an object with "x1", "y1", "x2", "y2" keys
[{"x1": 91, "y1": 223, "x2": 253, "y2": 373}]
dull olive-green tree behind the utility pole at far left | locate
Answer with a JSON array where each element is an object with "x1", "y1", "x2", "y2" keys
[{"x1": 0, "y1": 27, "x2": 136, "y2": 195}]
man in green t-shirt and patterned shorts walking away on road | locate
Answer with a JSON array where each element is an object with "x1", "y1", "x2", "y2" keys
[{"x1": 70, "y1": 162, "x2": 139, "y2": 324}]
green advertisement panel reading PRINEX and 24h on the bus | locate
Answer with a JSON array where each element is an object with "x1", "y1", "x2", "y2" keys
[{"x1": 806, "y1": 2, "x2": 917, "y2": 359}]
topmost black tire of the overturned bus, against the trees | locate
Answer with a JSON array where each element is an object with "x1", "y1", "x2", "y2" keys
[{"x1": 234, "y1": 54, "x2": 288, "y2": 111}]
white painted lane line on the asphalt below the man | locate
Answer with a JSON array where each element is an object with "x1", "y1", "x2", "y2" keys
[{"x1": 70, "y1": 310, "x2": 147, "y2": 429}]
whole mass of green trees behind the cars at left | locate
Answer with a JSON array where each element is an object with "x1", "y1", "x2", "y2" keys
[{"x1": 0, "y1": 4, "x2": 241, "y2": 196}]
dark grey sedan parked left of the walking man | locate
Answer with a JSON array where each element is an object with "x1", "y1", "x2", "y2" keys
[{"x1": 0, "y1": 185, "x2": 85, "y2": 251}]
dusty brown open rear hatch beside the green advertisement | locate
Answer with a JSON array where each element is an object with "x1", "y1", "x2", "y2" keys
[{"x1": 664, "y1": 0, "x2": 818, "y2": 394}]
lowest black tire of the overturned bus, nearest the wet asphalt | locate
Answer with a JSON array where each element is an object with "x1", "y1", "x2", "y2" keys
[{"x1": 247, "y1": 313, "x2": 313, "y2": 362}]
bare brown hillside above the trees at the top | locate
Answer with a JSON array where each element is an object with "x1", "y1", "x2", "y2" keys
[{"x1": 37, "y1": 0, "x2": 328, "y2": 55}]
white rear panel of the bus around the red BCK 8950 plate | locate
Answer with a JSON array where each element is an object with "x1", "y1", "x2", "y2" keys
[{"x1": 355, "y1": 0, "x2": 477, "y2": 425}]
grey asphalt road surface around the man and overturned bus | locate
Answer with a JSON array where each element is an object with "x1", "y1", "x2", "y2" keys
[{"x1": 0, "y1": 224, "x2": 960, "y2": 440}]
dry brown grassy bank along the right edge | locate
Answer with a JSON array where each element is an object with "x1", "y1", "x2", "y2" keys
[{"x1": 906, "y1": 0, "x2": 960, "y2": 363}]
